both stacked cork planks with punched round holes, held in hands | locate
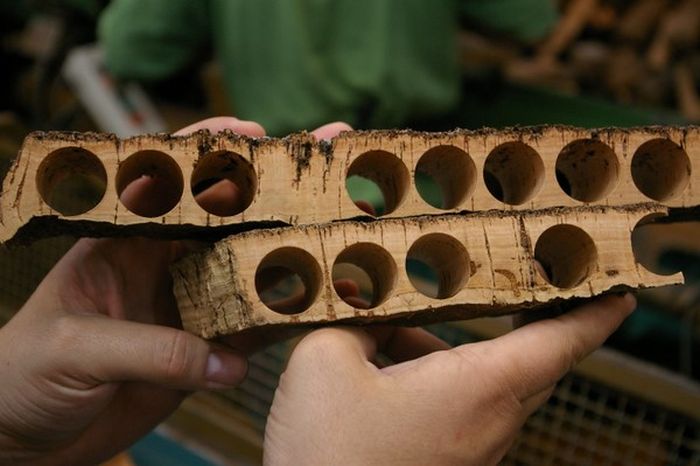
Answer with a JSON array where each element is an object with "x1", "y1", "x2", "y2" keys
[{"x1": 0, "y1": 126, "x2": 700, "y2": 337}]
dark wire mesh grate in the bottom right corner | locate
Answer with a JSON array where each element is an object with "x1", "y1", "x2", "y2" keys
[{"x1": 502, "y1": 374, "x2": 700, "y2": 466}]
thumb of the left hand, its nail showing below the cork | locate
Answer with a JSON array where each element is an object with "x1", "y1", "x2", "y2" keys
[{"x1": 58, "y1": 315, "x2": 248, "y2": 390}]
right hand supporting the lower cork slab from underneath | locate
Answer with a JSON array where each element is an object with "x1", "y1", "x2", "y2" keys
[{"x1": 264, "y1": 294, "x2": 635, "y2": 466}]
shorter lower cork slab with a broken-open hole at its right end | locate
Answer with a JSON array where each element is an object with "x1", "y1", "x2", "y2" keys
[{"x1": 173, "y1": 205, "x2": 682, "y2": 338}]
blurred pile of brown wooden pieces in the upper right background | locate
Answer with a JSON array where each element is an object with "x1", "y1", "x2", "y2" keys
[{"x1": 461, "y1": 0, "x2": 700, "y2": 121}]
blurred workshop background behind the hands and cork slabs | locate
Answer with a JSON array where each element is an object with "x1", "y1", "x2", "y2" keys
[{"x1": 0, "y1": 0, "x2": 700, "y2": 466}]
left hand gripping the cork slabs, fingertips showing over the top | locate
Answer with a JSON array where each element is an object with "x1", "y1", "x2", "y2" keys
[{"x1": 0, "y1": 118, "x2": 348, "y2": 465}]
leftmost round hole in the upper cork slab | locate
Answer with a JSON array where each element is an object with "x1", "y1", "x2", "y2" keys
[{"x1": 36, "y1": 147, "x2": 107, "y2": 216}]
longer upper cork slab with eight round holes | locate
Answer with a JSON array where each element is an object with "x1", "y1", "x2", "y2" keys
[{"x1": 0, "y1": 127, "x2": 700, "y2": 242}]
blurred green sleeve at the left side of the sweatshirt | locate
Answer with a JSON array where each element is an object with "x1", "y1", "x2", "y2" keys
[{"x1": 98, "y1": 0, "x2": 209, "y2": 81}]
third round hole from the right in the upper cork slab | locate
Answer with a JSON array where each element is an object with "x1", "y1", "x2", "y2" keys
[{"x1": 484, "y1": 141, "x2": 544, "y2": 205}]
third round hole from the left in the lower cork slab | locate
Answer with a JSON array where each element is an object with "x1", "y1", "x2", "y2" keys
[{"x1": 406, "y1": 233, "x2": 469, "y2": 299}]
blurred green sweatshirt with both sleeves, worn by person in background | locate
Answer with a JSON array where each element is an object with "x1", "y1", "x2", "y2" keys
[{"x1": 99, "y1": 0, "x2": 556, "y2": 135}]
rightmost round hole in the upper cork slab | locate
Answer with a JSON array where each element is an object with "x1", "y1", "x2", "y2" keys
[{"x1": 632, "y1": 138, "x2": 691, "y2": 201}]
